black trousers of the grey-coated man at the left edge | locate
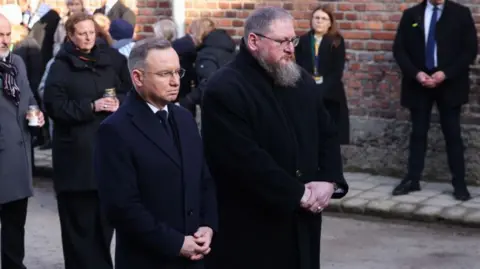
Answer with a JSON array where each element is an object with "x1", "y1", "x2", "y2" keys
[{"x1": 0, "y1": 198, "x2": 28, "y2": 269}]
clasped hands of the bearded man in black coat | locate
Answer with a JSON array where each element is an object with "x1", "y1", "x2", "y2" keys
[{"x1": 300, "y1": 182, "x2": 335, "y2": 213}]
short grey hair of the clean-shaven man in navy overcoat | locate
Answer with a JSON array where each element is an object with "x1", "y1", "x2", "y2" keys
[{"x1": 128, "y1": 37, "x2": 172, "y2": 73}]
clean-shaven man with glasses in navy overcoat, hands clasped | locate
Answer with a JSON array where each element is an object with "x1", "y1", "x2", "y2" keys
[{"x1": 94, "y1": 38, "x2": 217, "y2": 269}]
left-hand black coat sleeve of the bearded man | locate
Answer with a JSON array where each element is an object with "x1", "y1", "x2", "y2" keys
[{"x1": 202, "y1": 73, "x2": 305, "y2": 213}]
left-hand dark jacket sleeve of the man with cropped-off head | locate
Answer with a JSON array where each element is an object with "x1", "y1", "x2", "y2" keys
[{"x1": 393, "y1": 10, "x2": 421, "y2": 79}]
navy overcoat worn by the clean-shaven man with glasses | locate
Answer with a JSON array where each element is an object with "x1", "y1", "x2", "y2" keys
[{"x1": 94, "y1": 91, "x2": 217, "y2": 269}]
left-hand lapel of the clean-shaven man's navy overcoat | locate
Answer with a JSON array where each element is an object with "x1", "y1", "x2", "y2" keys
[{"x1": 125, "y1": 90, "x2": 182, "y2": 168}]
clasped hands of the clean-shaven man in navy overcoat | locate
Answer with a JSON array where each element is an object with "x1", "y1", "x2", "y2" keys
[{"x1": 180, "y1": 227, "x2": 213, "y2": 261}]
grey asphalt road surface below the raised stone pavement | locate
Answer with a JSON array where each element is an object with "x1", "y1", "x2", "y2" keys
[{"x1": 7, "y1": 178, "x2": 480, "y2": 269}]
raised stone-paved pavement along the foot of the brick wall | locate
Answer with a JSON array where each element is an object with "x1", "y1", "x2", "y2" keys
[{"x1": 35, "y1": 150, "x2": 480, "y2": 226}]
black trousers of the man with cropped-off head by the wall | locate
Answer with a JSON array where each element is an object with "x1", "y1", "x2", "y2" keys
[{"x1": 407, "y1": 94, "x2": 466, "y2": 188}]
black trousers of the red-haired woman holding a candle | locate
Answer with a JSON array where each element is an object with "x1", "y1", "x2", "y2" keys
[{"x1": 57, "y1": 191, "x2": 113, "y2": 269}]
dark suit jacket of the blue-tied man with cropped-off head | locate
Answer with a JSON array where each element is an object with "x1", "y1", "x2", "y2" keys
[{"x1": 393, "y1": 0, "x2": 478, "y2": 108}]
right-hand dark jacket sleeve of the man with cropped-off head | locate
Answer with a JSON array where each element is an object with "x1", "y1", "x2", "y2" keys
[{"x1": 442, "y1": 8, "x2": 478, "y2": 79}]
